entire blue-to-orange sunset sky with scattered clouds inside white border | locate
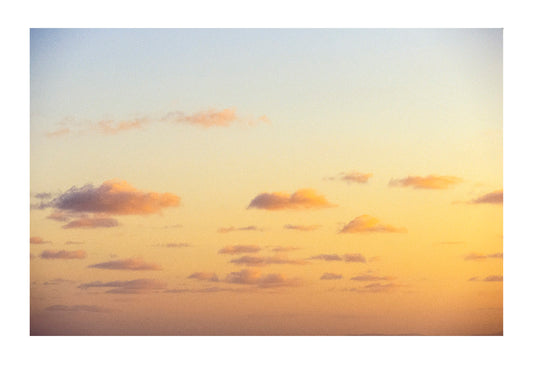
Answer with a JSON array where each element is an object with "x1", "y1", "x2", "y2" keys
[{"x1": 30, "y1": 29, "x2": 503, "y2": 335}]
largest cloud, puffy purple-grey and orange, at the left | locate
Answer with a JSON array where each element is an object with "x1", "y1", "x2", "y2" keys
[{"x1": 40, "y1": 179, "x2": 180, "y2": 215}]
